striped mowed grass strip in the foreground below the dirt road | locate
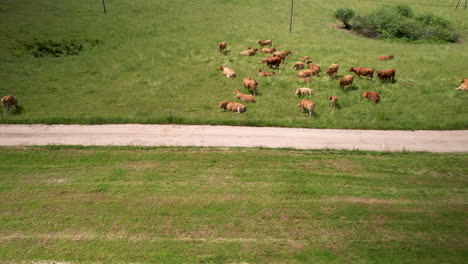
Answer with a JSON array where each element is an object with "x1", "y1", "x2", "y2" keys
[{"x1": 0, "y1": 147, "x2": 468, "y2": 263}]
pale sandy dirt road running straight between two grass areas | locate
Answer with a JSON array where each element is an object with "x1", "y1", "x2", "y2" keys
[{"x1": 0, "y1": 124, "x2": 468, "y2": 152}]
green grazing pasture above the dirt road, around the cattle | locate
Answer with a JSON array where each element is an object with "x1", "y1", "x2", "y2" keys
[{"x1": 0, "y1": 0, "x2": 468, "y2": 129}]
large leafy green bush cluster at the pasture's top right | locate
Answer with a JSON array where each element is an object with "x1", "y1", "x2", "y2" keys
[{"x1": 335, "y1": 5, "x2": 458, "y2": 42}]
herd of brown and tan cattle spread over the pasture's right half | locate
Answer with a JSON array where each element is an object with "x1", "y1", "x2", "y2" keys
[{"x1": 218, "y1": 40, "x2": 468, "y2": 115}]
